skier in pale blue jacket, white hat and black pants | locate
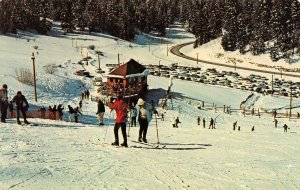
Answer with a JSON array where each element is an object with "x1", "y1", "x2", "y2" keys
[{"x1": 136, "y1": 98, "x2": 152, "y2": 143}]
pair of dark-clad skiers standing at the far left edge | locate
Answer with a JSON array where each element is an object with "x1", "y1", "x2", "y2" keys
[{"x1": 0, "y1": 84, "x2": 30, "y2": 125}]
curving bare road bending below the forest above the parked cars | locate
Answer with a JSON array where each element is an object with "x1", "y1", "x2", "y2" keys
[{"x1": 170, "y1": 42, "x2": 300, "y2": 77}]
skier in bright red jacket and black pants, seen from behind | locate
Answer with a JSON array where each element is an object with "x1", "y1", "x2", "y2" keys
[{"x1": 109, "y1": 95, "x2": 129, "y2": 147}]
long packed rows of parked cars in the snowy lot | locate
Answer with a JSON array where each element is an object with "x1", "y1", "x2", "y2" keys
[{"x1": 146, "y1": 64, "x2": 300, "y2": 98}]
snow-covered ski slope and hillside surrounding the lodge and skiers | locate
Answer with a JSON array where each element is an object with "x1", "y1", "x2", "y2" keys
[{"x1": 0, "y1": 24, "x2": 300, "y2": 190}]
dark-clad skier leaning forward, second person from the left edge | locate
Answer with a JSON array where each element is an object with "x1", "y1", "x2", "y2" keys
[{"x1": 12, "y1": 91, "x2": 30, "y2": 125}]
